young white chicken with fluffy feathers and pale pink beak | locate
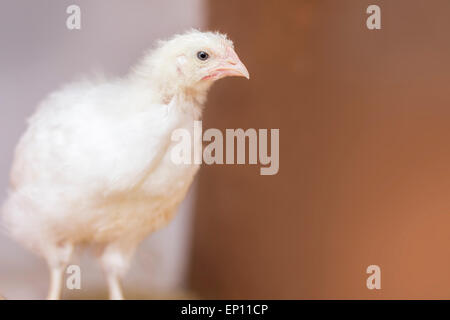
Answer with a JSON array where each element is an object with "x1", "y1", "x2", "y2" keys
[{"x1": 3, "y1": 30, "x2": 249, "y2": 299}]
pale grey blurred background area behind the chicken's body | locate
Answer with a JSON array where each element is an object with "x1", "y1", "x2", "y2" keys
[{"x1": 0, "y1": 0, "x2": 204, "y2": 298}]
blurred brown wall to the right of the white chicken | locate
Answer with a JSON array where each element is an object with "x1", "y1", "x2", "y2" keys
[{"x1": 191, "y1": 0, "x2": 450, "y2": 299}]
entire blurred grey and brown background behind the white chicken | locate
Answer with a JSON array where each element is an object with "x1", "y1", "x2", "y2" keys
[{"x1": 0, "y1": 0, "x2": 450, "y2": 299}]
